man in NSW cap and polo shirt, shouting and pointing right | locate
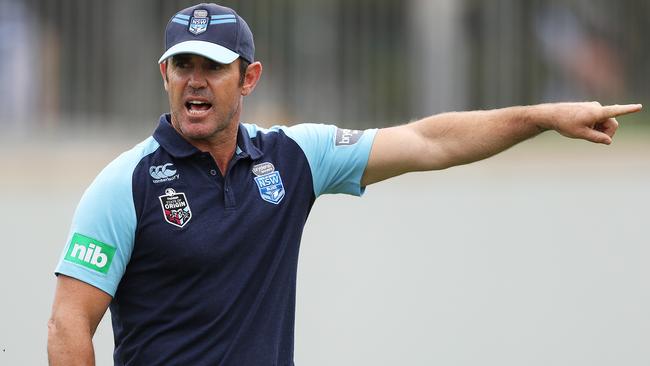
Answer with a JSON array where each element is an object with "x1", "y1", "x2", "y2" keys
[{"x1": 48, "y1": 4, "x2": 641, "y2": 366}]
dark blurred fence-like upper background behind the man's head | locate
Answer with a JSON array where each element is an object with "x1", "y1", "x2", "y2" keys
[{"x1": 0, "y1": 0, "x2": 650, "y2": 137}]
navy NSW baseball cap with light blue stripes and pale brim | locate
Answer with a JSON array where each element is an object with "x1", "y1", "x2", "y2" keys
[{"x1": 158, "y1": 3, "x2": 255, "y2": 64}]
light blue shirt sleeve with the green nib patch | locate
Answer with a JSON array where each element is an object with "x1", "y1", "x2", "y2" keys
[{"x1": 55, "y1": 137, "x2": 159, "y2": 296}]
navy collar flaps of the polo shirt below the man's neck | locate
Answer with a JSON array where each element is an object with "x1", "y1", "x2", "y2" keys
[{"x1": 153, "y1": 113, "x2": 263, "y2": 160}]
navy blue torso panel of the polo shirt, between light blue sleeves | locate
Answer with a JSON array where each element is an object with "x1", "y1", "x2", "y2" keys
[{"x1": 111, "y1": 116, "x2": 315, "y2": 365}]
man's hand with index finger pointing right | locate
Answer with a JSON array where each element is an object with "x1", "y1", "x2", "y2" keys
[{"x1": 541, "y1": 102, "x2": 642, "y2": 145}]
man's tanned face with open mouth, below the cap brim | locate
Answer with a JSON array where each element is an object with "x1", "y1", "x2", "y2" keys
[{"x1": 161, "y1": 54, "x2": 242, "y2": 140}]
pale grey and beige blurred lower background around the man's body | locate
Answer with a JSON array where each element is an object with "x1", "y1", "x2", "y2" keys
[{"x1": 0, "y1": 127, "x2": 650, "y2": 366}]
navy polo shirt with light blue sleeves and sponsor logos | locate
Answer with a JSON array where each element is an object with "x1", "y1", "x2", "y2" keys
[{"x1": 55, "y1": 114, "x2": 376, "y2": 366}]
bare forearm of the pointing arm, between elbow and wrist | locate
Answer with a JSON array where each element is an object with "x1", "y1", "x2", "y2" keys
[{"x1": 413, "y1": 105, "x2": 552, "y2": 170}]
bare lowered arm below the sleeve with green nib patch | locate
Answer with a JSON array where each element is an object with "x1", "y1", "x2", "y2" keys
[{"x1": 47, "y1": 274, "x2": 111, "y2": 366}]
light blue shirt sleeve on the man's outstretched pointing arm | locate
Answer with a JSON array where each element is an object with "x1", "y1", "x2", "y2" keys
[{"x1": 283, "y1": 123, "x2": 377, "y2": 197}]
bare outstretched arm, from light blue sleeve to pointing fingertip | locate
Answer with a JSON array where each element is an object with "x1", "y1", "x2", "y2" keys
[{"x1": 361, "y1": 102, "x2": 641, "y2": 186}]
